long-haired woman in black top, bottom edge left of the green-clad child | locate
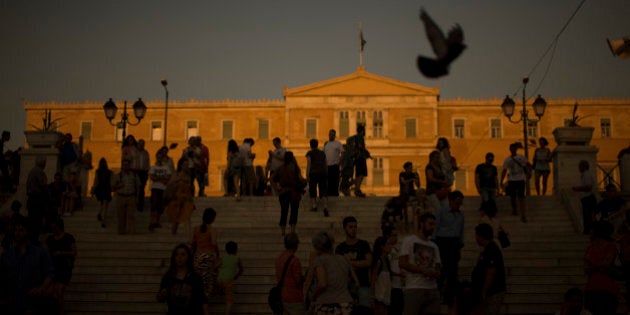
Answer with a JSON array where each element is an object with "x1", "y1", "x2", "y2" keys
[{"x1": 157, "y1": 244, "x2": 210, "y2": 315}]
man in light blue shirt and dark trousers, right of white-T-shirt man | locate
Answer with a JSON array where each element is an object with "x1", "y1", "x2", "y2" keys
[{"x1": 433, "y1": 190, "x2": 464, "y2": 309}]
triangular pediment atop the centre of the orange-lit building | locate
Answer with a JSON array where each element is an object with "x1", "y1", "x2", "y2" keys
[{"x1": 284, "y1": 67, "x2": 440, "y2": 97}]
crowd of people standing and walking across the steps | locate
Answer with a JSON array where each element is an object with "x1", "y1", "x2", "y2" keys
[{"x1": 0, "y1": 125, "x2": 630, "y2": 315}]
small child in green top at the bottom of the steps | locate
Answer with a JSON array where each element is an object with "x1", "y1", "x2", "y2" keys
[{"x1": 217, "y1": 241, "x2": 243, "y2": 315}]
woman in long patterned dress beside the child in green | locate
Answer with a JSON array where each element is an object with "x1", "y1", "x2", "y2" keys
[{"x1": 192, "y1": 208, "x2": 220, "y2": 298}]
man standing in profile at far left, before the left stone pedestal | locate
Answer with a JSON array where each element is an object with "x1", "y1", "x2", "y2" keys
[{"x1": 26, "y1": 155, "x2": 48, "y2": 245}]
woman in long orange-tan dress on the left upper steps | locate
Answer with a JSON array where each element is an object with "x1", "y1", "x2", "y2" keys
[{"x1": 166, "y1": 159, "x2": 195, "y2": 235}]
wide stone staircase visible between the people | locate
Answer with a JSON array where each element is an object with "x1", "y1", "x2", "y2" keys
[{"x1": 61, "y1": 197, "x2": 600, "y2": 315}]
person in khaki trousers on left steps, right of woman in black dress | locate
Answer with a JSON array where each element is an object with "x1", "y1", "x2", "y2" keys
[{"x1": 112, "y1": 159, "x2": 140, "y2": 234}]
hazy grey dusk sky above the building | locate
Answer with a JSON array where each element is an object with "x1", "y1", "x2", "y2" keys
[{"x1": 0, "y1": 0, "x2": 630, "y2": 149}]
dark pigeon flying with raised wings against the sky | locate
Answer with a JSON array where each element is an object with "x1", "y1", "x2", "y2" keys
[{"x1": 417, "y1": 9, "x2": 466, "y2": 78}]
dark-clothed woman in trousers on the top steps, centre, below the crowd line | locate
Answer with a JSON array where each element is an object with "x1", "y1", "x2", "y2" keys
[{"x1": 273, "y1": 151, "x2": 306, "y2": 236}]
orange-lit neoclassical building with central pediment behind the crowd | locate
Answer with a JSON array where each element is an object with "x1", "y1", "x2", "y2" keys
[{"x1": 24, "y1": 67, "x2": 630, "y2": 195}]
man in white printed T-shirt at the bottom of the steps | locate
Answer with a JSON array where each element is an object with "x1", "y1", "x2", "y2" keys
[{"x1": 398, "y1": 213, "x2": 442, "y2": 315}]
